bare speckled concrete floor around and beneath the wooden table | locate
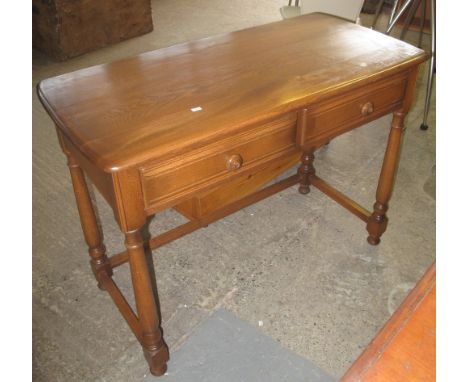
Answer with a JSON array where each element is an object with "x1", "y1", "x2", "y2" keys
[{"x1": 32, "y1": 0, "x2": 436, "y2": 382}]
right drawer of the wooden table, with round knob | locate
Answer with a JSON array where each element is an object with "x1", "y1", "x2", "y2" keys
[{"x1": 297, "y1": 76, "x2": 407, "y2": 147}]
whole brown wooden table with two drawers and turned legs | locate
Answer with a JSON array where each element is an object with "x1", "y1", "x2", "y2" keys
[{"x1": 38, "y1": 14, "x2": 427, "y2": 375}]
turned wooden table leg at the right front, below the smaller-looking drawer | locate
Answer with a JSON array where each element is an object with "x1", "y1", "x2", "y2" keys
[{"x1": 367, "y1": 112, "x2": 406, "y2": 245}]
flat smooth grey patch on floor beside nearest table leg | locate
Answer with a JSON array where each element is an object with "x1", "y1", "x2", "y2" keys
[{"x1": 144, "y1": 309, "x2": 335, "y2": 382}]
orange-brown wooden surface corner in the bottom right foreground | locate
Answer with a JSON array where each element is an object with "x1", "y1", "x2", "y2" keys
[{"x1": 341, "y1": 263, "x2": 436, "y2": 382}]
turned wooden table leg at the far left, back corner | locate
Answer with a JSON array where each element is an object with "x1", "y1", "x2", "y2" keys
[{"x1": 68, "y1": 155, "x2": 112, "y2": 289}]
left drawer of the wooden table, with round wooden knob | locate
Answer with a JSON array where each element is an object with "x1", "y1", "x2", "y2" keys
[{"x1": 140, "y1": 113, "x2": 297, "y2": 214}]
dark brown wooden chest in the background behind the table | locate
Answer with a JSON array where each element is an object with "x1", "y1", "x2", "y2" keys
[{"x1": 32, "y1": 0, "x2": 153, "y2": 61}]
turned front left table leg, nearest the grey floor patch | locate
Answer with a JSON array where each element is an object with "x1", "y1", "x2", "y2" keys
[{"x1": 125, "y1": 229, "x2": 169, "y2": 375}]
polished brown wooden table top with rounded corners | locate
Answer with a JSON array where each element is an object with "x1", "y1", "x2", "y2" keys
[{"x1": 38, "y1": 13, "x2": 427, "y2": 172}]
